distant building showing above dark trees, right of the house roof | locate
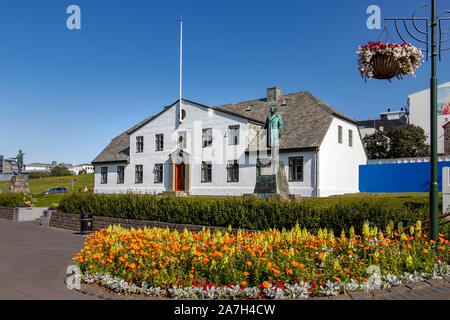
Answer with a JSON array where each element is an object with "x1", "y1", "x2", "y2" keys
[{"x1": 359, "y1": 108, "x2": 409, "y2": 138}]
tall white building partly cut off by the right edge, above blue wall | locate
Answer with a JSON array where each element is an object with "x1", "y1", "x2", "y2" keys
[{"x1": 408, "y1": 82, "x2": 450, "y2": 154}]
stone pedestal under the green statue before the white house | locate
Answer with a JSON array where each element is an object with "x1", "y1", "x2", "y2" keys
[{"x1": 254, "y1": 161, "x2": 289, "y2": 199}]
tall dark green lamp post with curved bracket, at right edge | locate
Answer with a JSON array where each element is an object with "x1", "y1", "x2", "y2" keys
[{"x1": 385, "y1": 0, "x2": 450, "y2": 241}]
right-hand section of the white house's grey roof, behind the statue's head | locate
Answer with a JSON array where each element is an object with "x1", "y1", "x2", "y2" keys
[{"x1": 216, "y1": 91, "x2": 358, "y2": 149}]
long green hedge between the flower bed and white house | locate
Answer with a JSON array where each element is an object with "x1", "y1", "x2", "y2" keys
[{"x1": 58, "y1": 194, "x2": 428, "y2": 232}]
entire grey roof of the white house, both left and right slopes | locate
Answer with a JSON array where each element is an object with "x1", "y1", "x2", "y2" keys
[{"x1": 92, "y1": 91, "x2": 358, "y2": 164}]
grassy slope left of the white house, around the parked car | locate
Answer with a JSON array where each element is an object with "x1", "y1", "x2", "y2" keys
[{"x1": 0, "y1": 173, "x2": 94, "y2": 207}]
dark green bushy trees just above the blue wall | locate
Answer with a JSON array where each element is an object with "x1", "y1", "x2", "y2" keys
[{"x1": 363, "y1": 124, "x2": 430, "y2": 159}]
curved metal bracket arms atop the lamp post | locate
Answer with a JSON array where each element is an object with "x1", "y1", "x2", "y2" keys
[{"x1": 384, "y1": 4, "x2": 450, "y2": 60}]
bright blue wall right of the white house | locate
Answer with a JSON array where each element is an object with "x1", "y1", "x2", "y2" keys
[{"x1": 359, "y1": 161, "x2": 450, "y2": 192}]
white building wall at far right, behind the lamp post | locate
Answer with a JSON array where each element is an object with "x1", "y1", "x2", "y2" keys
[{"x1": 408, "y1": 82, "x2": 450, "y2": 153}]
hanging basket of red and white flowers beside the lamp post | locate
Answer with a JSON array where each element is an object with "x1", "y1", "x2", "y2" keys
[{"x1": 356, "y1": 41, "x2": 423, "y2": 81}]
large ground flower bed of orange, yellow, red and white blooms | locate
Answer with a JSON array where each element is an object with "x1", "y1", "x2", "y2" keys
[{"x1": 74, "y1": 222, "x2": 450, "y2": 298}]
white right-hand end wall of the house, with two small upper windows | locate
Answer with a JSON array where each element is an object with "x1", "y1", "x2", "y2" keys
[{"x1": 318, "y1": 117, "x2": 367, "y2": 197}]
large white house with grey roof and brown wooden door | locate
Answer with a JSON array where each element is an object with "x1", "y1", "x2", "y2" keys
[{"x1": 92, "y1": 88, "x2": 367, "y2": 197}]
